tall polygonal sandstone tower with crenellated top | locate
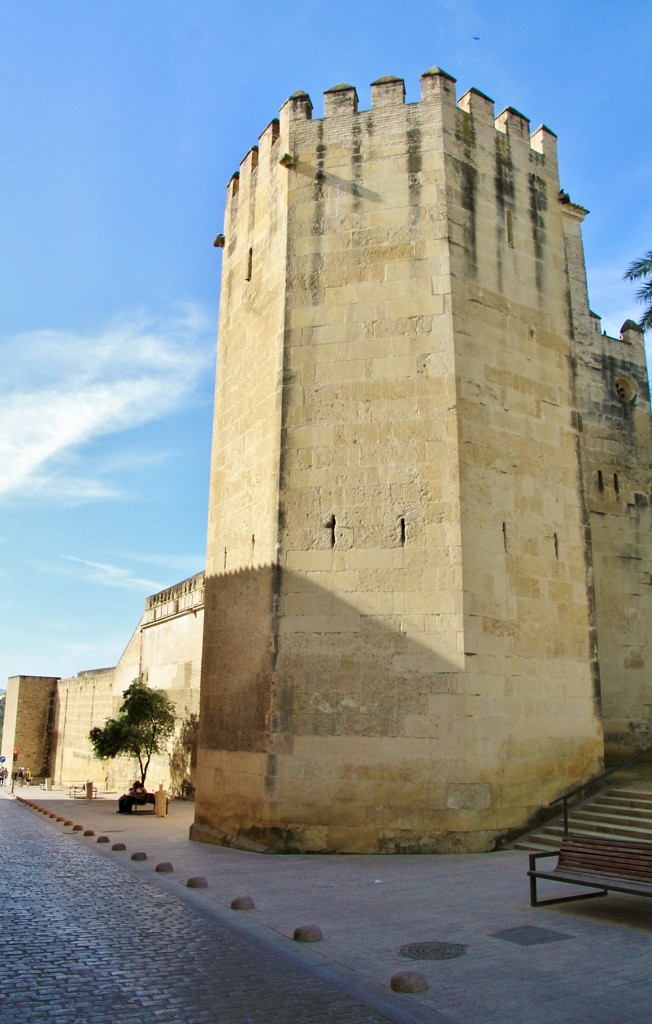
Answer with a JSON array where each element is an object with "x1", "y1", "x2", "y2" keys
[{"x1": 190, "y1": 68, "x2": 652, "y2": 852}]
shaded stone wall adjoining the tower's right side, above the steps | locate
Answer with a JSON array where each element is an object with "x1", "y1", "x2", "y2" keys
[{"x1": 578, "y1": 316, "x2": 652, "y2": 762}]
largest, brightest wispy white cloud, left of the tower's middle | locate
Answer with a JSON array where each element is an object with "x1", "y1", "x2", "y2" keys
[{"x1": 0, "y1": 306, "x2": 214, "y2": 503}]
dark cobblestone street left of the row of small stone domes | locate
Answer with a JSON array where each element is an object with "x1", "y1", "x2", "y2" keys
[{"x1": 0, "y1": 801, "x2": 421, "y2": 1024}]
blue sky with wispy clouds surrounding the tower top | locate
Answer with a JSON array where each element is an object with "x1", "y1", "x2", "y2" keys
[{"x1": 0, "y1": 0, "x2": 652, "y2": 688}]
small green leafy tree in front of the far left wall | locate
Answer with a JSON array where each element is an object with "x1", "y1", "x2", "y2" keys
[{"x1": 88, "y1": 679, "x2": 175, "y2": 785}]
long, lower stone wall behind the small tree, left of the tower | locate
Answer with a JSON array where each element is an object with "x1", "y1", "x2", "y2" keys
[{"x1": 8, "y1": 572, "x2": 204, "y2": 796}]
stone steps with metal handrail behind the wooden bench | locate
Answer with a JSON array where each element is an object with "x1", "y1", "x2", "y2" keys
[{"x1": 513, "y1": 779, "x2": 652, "y2": 852}]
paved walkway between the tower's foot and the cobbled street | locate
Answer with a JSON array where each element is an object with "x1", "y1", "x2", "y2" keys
[{"x1": 5, "y1": 787, "x2": 652, "y2": 1024}]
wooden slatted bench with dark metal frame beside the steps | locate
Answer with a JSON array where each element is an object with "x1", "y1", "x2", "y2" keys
[{"x1": 527, "y1": 836, "x2": 652, "y2": 906}]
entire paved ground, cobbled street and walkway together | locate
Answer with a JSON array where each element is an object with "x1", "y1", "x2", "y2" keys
[{"x1": 0, "y1": 787, "x2": 652, "y2": 1024}]
